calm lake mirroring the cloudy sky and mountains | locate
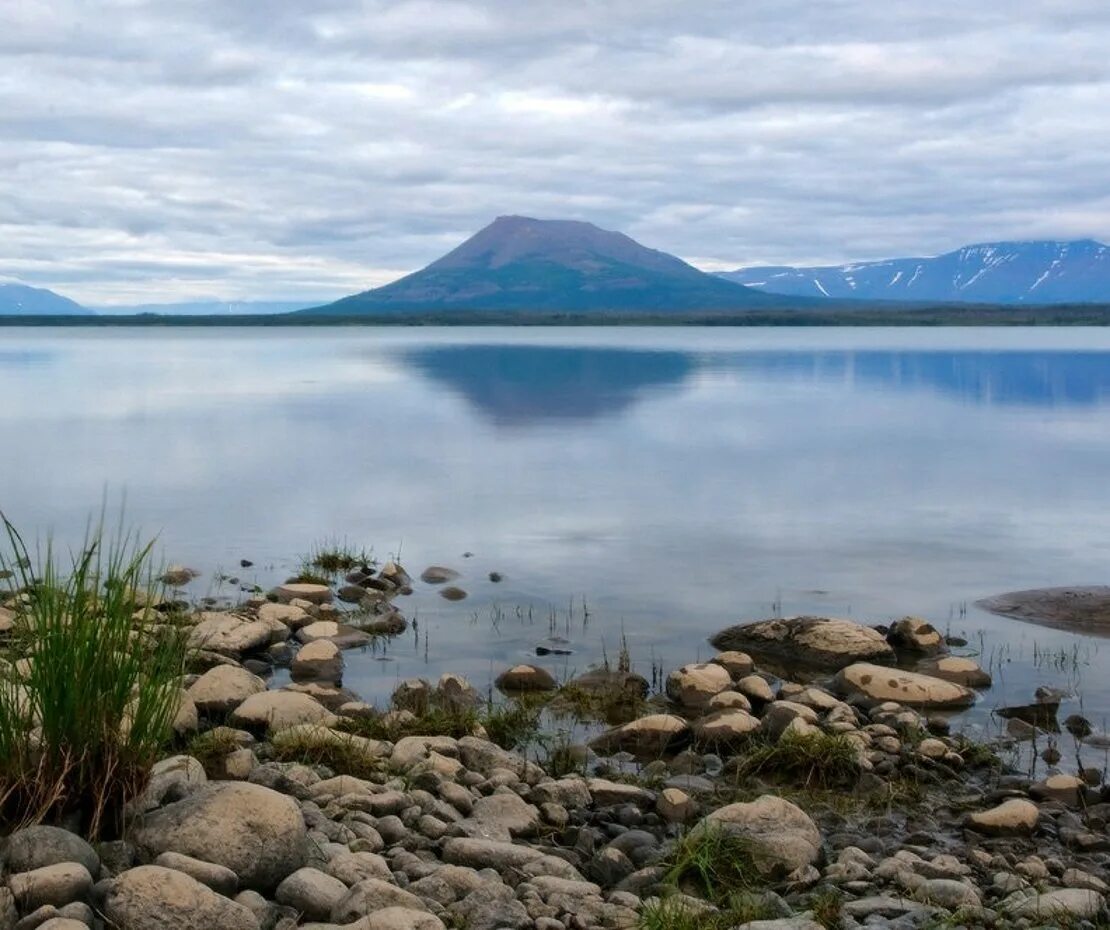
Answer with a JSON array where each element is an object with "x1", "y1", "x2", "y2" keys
[{"x1": 0, "y1": 327, "x2": 1110, "y2": 754}]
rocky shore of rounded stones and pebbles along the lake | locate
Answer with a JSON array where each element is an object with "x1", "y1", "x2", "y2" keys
[{"x1": 0, "y1": 563, "x2": 1110, "y2": 930}]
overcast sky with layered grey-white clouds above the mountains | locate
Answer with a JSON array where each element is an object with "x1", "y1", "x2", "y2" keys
[{"x1": 0, "y1": 0, "x2": 1110, "y2": 305}]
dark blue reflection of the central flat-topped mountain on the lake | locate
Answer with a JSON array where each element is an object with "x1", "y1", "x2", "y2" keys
[{"x1": 406, "y1": 345, "x2": 695, "y2": 426}]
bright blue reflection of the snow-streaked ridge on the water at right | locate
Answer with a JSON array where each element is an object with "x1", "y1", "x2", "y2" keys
[{"x1": 725, "y1": 350, "x2": 1110, "y2": 406}]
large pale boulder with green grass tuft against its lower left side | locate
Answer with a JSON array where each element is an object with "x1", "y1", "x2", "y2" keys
[{"x1": 695, "y1": 795, "x2": 821, "y2": 878}]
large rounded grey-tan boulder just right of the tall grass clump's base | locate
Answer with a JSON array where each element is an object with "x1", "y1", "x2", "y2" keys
[{"x1": 131, "y1": 782, "x2": 307, "y2": 892}]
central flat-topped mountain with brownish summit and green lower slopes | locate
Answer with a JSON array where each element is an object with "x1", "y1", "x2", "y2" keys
[{"x1": 304, "y1": 216, "x2": 798, "y2": 315}]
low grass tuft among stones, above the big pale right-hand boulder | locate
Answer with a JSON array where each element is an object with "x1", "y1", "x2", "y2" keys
[{"x1": 736, "y1": 732, "x2": 860, "y2": 788}]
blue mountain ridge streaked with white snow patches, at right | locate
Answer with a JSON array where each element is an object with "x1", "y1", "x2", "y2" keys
[{"x1": 720, "y1": 239, "x2": 1110, "y2": 304}]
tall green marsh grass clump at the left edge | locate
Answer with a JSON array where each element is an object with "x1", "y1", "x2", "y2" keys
[{"x1": 0, "y1": 515, "x2": 188, "y2": 837}]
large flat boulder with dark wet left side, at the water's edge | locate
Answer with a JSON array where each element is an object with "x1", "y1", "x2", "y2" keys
[{"x1": 710, "y1": 617, "x2": 895, "y2": 670}]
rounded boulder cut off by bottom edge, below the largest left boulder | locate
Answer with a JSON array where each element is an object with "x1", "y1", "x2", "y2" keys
[{"x1": 102, "y1": 866, "x2": 259, "y2": 930}]
